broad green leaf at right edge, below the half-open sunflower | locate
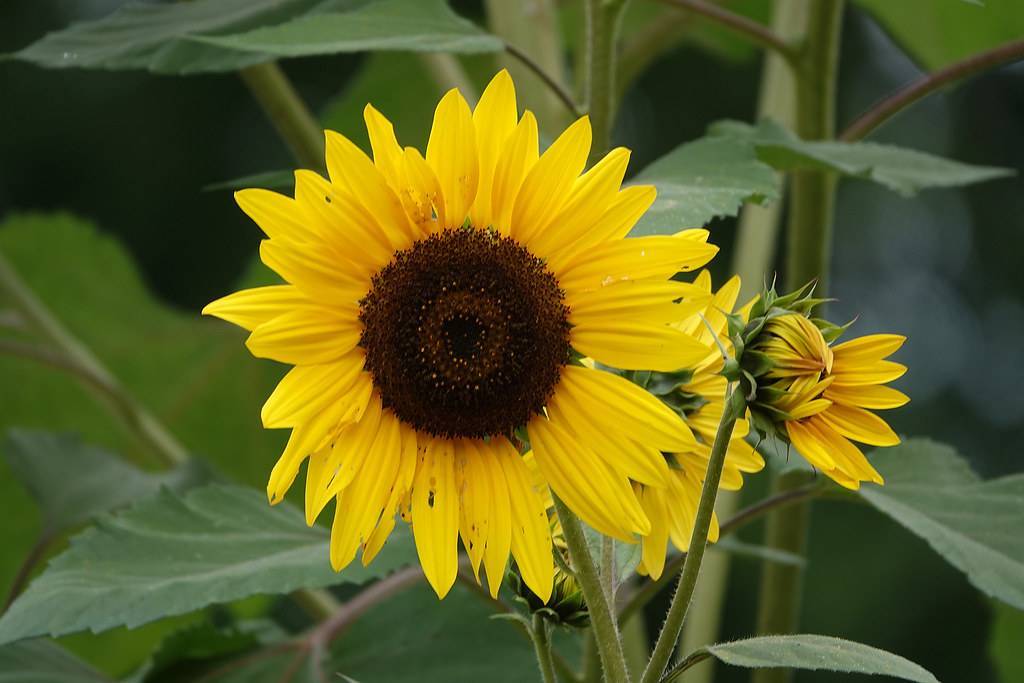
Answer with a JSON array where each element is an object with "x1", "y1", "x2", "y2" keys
[{"x1": 859, "y1": 439, "x2": 1024, "y2": 609}]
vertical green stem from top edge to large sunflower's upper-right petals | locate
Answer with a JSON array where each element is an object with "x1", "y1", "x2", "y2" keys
[{"x1": 586, "y1": 0, "x2": 626, "y2": 162}]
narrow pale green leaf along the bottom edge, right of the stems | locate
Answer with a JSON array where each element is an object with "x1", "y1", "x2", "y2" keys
[{"x1": 687, "y1": 634, "x2": 938, "y2": 683}]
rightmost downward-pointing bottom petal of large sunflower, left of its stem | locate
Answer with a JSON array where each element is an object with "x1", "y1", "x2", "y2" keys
[{"x1": 487, "y1": 439, "x2": 555, "y2": 602}]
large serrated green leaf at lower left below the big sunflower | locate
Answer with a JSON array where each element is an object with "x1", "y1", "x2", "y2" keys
[{"x1": 0, "y1": 485, "x2": 413, "y2": 643}]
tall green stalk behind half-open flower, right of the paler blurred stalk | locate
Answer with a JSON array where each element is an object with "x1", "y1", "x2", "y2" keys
[{"x1": 753, "y1": 0, "x2": 845, "y2": 683}]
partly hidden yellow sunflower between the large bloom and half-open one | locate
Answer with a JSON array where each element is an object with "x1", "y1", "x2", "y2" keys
[{"x1": 636, "y1": 270, "x2": 764, "y2": 579}]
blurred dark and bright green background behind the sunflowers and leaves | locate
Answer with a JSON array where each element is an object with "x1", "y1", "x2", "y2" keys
[{"x1": 0, "y1": 0, "x2": 1024, "y2": 683}]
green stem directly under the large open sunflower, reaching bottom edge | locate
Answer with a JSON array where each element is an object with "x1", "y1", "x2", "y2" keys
[{"x1": 552, "y1": 495, "x2": 630, "y2": 683}]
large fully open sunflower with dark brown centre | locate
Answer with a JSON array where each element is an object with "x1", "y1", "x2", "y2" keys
[{"x1": 204, "y1": 71, "x2": 717, "y2": 600}]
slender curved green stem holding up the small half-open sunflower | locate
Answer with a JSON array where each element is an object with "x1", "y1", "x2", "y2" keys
[{"x1": 640, "y1": 389, "x2": 746, "y2": 683}]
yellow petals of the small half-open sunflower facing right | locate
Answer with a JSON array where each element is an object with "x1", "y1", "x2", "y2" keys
[{"x1": 751, "y1": 312, "x2": 909, "y2": 489}]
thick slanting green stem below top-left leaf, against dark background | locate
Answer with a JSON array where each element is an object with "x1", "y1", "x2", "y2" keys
[{"x1": 239, "y1": 61, "x2": 325, "y2": 170}]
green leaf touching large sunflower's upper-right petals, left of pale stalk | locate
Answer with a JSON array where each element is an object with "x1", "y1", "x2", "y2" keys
[{"x1": 632, "y1": 137, "x2": 778, "y2": 237}]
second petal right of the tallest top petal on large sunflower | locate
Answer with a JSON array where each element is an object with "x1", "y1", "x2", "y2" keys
[{"x1": 511, "y1": 117, "x2": 591, "y2": 244}]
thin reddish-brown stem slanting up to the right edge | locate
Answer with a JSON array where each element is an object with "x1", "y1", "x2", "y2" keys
[{"x1": 839, "y1": 40, "x2": 1024, "y2": 142}]
